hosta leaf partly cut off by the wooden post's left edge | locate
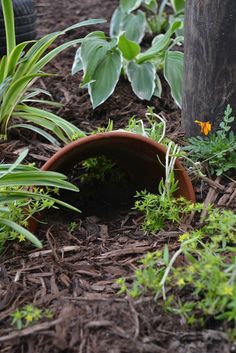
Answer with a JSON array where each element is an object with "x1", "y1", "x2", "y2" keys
[{"x1": 164, "y1": 51, "x2": 184, "y2": 108}]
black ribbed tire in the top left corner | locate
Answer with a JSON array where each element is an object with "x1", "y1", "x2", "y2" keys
[{"x1": 0, "y1": 0, "x2": 36, "y2": 56}]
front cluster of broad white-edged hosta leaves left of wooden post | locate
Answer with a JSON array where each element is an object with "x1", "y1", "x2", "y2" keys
[{"x1": 72, "y1": 21, "x2": 184, "y2": 108}]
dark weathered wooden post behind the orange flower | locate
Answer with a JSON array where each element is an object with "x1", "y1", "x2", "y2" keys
[{"x1": 182, "y1": 0, "x2": 236, "y2": 136}]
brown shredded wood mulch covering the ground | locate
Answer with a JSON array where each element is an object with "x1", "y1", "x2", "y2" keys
[{"x1": 0, "y1": 0, "x2": 236, "y2": 353}]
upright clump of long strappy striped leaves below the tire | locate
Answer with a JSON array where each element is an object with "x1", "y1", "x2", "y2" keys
[{"x1": 0, "y1": 0, "x2": 104, "y2": 143}]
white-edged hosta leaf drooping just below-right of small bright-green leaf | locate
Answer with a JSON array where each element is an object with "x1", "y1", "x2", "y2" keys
[{"x1": 127, "y1": 61, "x2": 156, "y2": 100}]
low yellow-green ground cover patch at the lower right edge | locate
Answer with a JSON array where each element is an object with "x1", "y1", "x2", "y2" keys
[{"x1": 117, "y1": 206, "x2": 236, "y2": 337}]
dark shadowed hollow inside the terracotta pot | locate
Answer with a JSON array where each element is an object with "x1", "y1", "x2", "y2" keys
[{"x1": 53, "y1": 155, "x2": 139, "y2": 218}]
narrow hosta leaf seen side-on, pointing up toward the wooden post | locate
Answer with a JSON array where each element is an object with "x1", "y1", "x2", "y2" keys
[{"x1": 137, "y1": 21, "x2": 182, "y2": 63}]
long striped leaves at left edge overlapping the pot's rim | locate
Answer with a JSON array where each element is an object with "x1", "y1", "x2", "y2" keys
[{"x1": 0, "y1": 150, "x2": 79, "y2": 251}]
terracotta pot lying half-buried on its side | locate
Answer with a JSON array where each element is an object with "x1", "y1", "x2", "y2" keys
[{"x1": 31, "y1": 131, "x2": 195, "y2": 229}]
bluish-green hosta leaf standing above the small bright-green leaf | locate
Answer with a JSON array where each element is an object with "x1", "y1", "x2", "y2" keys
[{"x1": 121, "y1": 10, "x2": 146, "y2": 43}]
